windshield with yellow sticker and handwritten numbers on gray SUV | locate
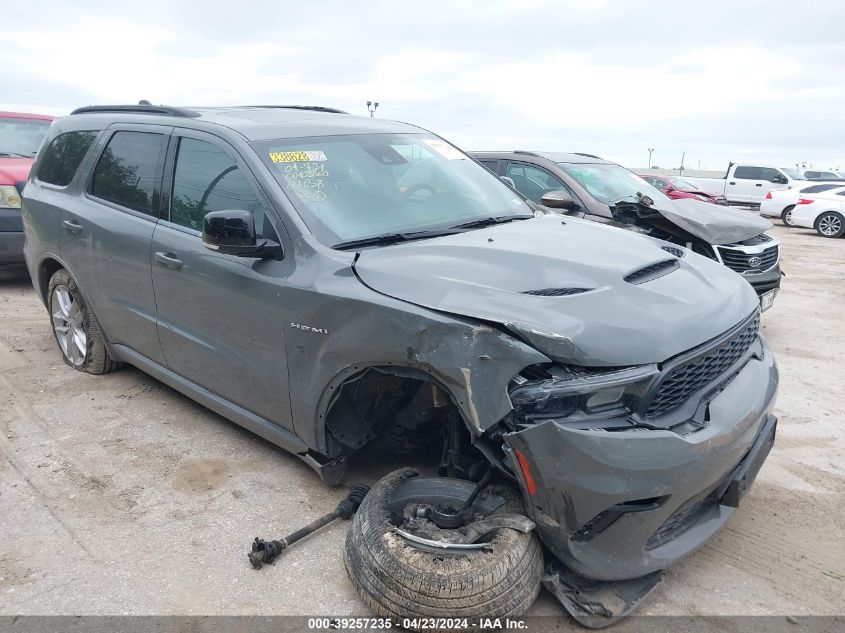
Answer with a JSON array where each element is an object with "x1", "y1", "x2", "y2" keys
[{"x1": 252, "y1": 134, "x2": 532, "y2": 245}]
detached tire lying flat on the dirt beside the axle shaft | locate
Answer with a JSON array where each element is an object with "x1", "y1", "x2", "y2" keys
[{"x1": 344, "y1": 468, "x2": 543, "y2": 626}]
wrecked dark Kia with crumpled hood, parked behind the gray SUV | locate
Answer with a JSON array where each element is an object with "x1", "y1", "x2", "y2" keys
[{"x1": 472, "y1": 151, "x2": 781, "y2": 310}]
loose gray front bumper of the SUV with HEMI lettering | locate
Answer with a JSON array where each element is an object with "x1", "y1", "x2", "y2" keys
[{"x1": 505, "y1": 338, "x2": 778, "y2": 580}]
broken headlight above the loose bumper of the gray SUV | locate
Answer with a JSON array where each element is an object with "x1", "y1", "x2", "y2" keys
[{"x1": 510, "y1": 365, "x2": 659, "y2": 423}]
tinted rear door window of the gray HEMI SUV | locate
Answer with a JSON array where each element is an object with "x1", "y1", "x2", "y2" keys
[{"x1": 91, "y1": 132, "x2": 164, "y2": 215}]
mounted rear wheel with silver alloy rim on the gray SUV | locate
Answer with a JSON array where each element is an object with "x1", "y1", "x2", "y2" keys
[{"x1": 47, "y1": 268, "x2": 120, "y2": 375}]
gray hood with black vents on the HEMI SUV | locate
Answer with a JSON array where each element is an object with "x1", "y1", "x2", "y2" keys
[{"x1": 354, "y1": 215, "x2": 757, "y2": 366}]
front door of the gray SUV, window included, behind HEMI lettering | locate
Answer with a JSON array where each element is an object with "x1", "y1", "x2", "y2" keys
[{"x1": 151, "y1": 129, "x2": 293, "y2": 429}]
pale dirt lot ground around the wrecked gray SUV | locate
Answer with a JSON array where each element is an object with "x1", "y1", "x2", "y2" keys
[{"x1": 0, "y1": 226, "x2": 845, "y2": 615}]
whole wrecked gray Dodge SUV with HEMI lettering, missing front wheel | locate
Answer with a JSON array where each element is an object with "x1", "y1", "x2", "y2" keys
[{"x1": 23, "y1": 105, "x2": 778, "y2": 624}]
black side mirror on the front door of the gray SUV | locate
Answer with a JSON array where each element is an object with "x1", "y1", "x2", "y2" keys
[{"x1": 202, "y1": 209, "x2": 282, "y2": 259}]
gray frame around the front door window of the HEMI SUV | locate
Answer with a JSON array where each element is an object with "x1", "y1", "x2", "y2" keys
[{"x1": 158, "y1": 127, "x2": 288, "y2": 244}]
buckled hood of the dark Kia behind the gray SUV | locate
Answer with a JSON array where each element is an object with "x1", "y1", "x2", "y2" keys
[{"x1": 653, "y1": 198, "x2": 772, "y2": 244}]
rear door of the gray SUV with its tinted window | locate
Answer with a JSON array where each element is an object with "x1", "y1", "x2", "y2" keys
[{"x1": 60, "y1": 125, "x2": 172, "y2": 363}]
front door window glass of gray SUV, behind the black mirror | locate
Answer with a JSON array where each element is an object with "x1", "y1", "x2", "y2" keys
[{"x1": 170, "y1": 138, "x2": 266, "y2": 237}]
